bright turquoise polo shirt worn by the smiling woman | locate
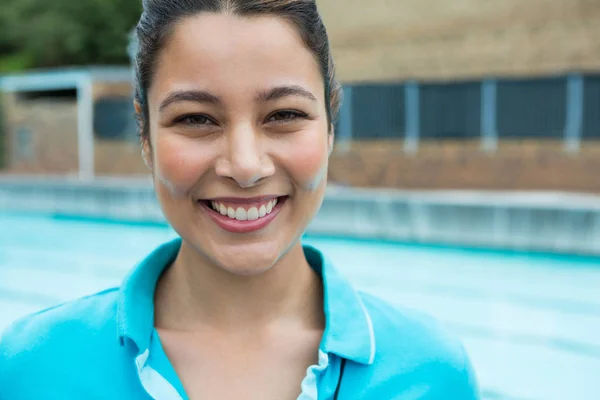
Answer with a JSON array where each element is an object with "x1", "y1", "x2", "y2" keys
[{"x1": 0, "y1": 239, "x2": 479, "y2": 400}]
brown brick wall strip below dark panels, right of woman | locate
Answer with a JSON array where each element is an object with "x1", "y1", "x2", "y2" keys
[{"x1": 329, "y1": 140, "x2": 600, "y2": 193}]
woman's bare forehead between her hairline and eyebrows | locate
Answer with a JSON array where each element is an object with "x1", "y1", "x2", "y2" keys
[{"x1": 150, "y1": 13, "x2": 324, "y2": 98}]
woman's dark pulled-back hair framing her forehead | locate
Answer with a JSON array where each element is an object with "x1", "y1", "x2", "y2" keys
[{"x1": 133, "y1": 0, "x2": 341, "y2": 140}]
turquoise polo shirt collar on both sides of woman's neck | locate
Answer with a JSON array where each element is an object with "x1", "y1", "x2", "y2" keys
[{"x1": 117, "y1": 238, "x2": 375, "y2": 364}]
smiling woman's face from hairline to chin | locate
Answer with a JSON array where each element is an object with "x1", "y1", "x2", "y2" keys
[{"x1": 144, "y1": 14, "x2": 333, "y2": 275}]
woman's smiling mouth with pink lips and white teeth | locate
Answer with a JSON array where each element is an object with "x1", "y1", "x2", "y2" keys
[{"x1": 198, "y1": 196, "x2": 288, "y2": 233}]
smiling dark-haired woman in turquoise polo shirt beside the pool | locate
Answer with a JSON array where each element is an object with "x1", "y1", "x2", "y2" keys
[{"x1": 0, "y1": 0, "x2": 477, "y2": 400}]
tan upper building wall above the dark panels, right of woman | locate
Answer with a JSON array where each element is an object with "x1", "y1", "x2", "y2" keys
[{"x1": 317, "y1": 0, "x2": 600, "y2": 82}]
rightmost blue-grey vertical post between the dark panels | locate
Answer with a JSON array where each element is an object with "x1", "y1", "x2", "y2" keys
[{"x1": 565, "y1": 74, "x2": 584, "y2": 153}]
